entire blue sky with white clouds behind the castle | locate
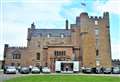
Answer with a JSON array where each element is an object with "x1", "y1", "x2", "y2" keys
[{"x1": 0, "y1": 0, "x2": 120, "y2": 60}]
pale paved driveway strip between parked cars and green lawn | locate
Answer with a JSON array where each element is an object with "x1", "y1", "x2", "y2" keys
[{"x1": 0, "y1": 71, "x2": 120, "y2": 82}]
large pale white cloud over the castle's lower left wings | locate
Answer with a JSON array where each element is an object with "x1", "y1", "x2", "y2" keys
[{"x1": 0, "y1": 0, "x2": 74, "y2": 58}]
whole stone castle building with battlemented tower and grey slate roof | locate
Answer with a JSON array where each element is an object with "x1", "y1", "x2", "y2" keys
[{"x1": 4, "y1": 12, "x2": 112, "y2": 71}]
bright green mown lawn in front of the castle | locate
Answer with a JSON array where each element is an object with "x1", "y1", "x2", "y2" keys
[{"x1": 4, "y1": 75, "x2": 120, "y2": 82}]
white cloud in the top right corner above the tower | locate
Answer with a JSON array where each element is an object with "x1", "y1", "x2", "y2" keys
[{"x1": 94, "y1": 0, "x2": 120, "y2": 15}]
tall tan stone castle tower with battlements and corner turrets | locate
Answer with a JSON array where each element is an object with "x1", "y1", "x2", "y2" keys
[{"x1": 80, "y1": 13, "x2": 112, "y2": 67}]
